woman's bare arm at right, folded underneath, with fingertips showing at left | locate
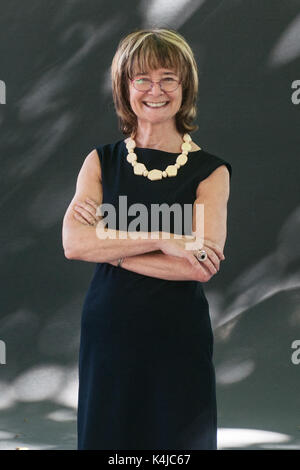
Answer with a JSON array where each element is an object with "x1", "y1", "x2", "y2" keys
[{"x1": 71, "y1": 162, "x2": 229, "y2": 282}]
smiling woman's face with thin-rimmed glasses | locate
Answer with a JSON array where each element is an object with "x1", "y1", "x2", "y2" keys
[{"x1": 129, "y1": 68, "x2": 182, "y2": 127}]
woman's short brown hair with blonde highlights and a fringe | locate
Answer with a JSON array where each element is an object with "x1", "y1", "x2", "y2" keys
[{"x1": 111, "y1": 28, "x2": 199, "y2": 135}]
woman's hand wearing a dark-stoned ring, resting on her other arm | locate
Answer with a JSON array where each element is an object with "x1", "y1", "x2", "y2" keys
[{"x1": 159, "y1": 234, "x2": 225, "y2": 280}]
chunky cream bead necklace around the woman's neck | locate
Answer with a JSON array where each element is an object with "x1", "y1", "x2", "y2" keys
[{"x1": 126, "y1": 134, "x2": 197, "y2": 181}]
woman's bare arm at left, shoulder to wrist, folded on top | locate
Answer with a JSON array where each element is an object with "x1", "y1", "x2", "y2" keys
[{"x1": 62, "y1": 149, "x2": 159, "y2": 263}]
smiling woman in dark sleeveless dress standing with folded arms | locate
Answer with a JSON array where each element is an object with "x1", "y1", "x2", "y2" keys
[{"x1": 63, "y1": 29, "x2": 231, "y2": 450}]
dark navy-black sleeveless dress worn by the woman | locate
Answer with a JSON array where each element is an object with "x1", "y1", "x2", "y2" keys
[{"x1": 77, "y1": 140, "x2": 232, "y2": 450}]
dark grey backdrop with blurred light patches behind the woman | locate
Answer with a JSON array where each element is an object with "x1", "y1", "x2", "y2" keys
[{"x1": 0, "y1": 0, "x2": 300, "y2": 449}]
